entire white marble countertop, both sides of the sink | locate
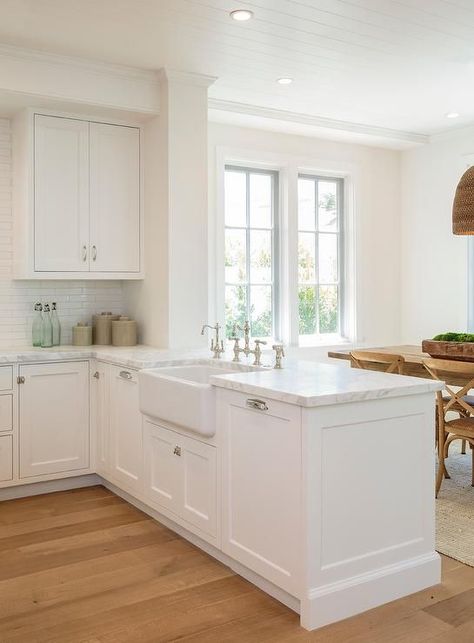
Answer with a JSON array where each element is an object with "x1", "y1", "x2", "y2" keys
[{"x1": 0, "y1": 345, "x2": 442, "y2": 407}]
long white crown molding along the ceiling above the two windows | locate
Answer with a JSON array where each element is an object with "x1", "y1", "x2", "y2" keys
[{"x1": 209, "y1": 98, "x2": 430, "y2": 145}]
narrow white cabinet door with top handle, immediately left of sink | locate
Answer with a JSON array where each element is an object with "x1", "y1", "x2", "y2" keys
[{"x1": 110, "y1": 367, "x2": 143, "y2": 491}]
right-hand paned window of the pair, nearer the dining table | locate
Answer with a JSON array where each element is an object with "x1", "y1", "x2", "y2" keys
[{"x1": 298, "y1": 175, "x2": 343, "y2": 343}]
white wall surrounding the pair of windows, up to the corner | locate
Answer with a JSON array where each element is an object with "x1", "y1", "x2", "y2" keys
[{"x1": 209, "y1": 123, "x2": 400, "y2": 357}]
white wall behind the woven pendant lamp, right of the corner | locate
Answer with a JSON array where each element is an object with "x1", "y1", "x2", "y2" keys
[{"x1": 401, "y1": 128, "x2": 474, "y2": 344}]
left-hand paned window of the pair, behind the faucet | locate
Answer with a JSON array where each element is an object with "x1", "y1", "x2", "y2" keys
[{"x1": 224, "y1": 166, "x2": 278, "y2": 337}]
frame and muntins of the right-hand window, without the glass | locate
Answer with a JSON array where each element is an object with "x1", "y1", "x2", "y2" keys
[{"x1": 295, "y1": 170, "x2": 346, "y2": 346}]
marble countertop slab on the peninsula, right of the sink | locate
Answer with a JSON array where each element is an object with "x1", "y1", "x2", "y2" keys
[{"x1": 211, "y1": 360, "x2": 443, "y2": 407}]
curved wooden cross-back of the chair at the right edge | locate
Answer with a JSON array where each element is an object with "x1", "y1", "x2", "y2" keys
[{"x1": 423, "y1": 358, "x2": 474, "y2": 415}]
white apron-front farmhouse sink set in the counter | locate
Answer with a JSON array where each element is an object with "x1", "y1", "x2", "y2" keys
[{"x1": 138, "y1": 364, "x2": 239, "y2": 437}]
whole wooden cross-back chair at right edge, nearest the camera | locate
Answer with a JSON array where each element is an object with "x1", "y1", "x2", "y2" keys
[{"x1": 423, "y1": 359, "x2": 474, "y2": 496}]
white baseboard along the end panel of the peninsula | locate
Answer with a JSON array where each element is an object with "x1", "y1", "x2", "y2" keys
[{"x1": 301, "y1": 552, "x2": 441, "y2": 630}]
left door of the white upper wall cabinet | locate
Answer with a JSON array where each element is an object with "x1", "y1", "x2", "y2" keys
[{"x1": 34, "y1": 114, "x2": 89, "y2": 272}]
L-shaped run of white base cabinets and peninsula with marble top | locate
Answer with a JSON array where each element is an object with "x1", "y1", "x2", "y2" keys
[{"x1": 0, "y1": 347, "x2": 440, "y2": 629}]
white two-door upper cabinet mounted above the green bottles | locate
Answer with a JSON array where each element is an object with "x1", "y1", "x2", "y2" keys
[{"x1": 13, "y1": 112, "x2": 143, "y2": 279}]
